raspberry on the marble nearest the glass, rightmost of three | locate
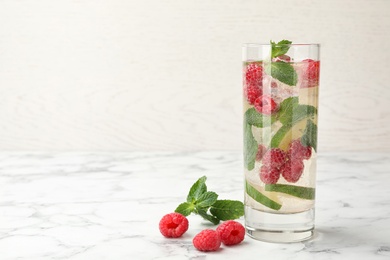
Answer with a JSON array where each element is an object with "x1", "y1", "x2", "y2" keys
[{"x1": 217, "y1": 220, "x2": 245, "y2": 246}]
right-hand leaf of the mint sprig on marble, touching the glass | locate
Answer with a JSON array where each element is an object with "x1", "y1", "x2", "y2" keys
[{"x1": 210, "y1": 200, "x2": 244, "y2": 220}]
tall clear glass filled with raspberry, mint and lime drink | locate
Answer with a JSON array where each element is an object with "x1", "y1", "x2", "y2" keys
[{"x1": 243, "y1": 44, "x2": 320, "y2": 243}]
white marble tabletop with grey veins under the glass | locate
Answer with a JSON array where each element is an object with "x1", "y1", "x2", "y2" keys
[{"x1": 0, "y1": 152, "x2": 390, "y2": 260}]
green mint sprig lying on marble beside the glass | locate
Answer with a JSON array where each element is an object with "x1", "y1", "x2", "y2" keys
[{"x1": 175, "y1": 176, "x2": 244, "y2": 225}]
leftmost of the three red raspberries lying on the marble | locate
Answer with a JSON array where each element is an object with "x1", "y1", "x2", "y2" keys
[{"x1": 159, "y1": 213, "x2": 188, "y2": 238}]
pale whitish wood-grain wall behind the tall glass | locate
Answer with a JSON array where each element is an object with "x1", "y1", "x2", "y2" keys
[{"x1": 0, "y1": 0, "x2": 390, "y2": 152}]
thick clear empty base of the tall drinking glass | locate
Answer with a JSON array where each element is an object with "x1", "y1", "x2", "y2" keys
[{"x1": 245, "y1": 206, "x2": 314, "y2": 243}]
